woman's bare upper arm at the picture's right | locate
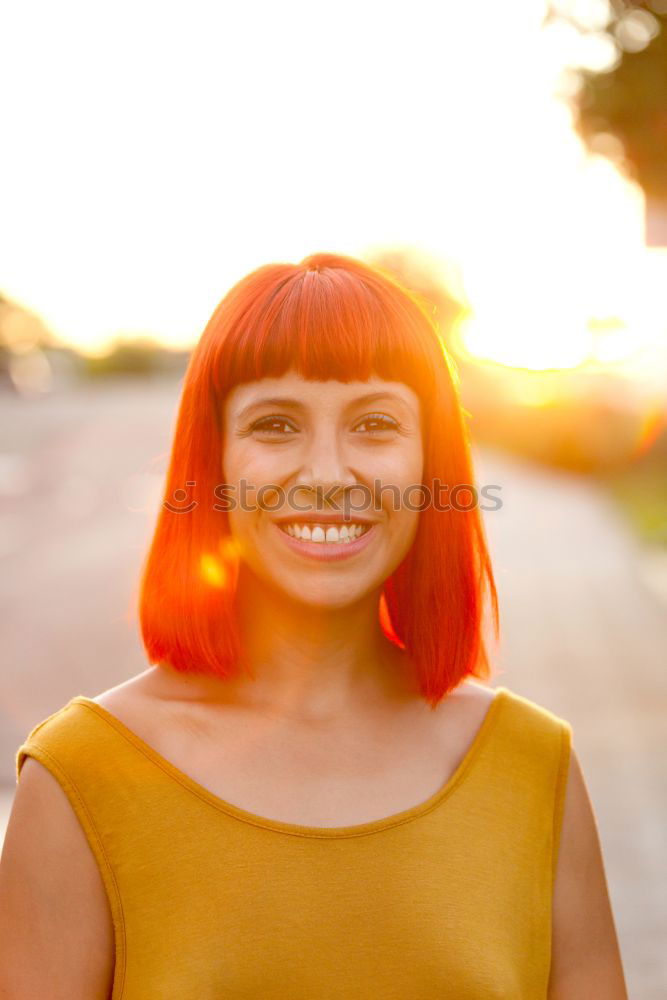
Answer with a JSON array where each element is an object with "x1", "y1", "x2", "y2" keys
[{"x1": 548, "y1": 750, "x2": 628, "y2": 1000}]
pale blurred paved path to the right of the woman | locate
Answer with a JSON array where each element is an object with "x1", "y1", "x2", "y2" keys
[{"x1": 477, "y1": 454, "x2": 667, "y2": 1000}]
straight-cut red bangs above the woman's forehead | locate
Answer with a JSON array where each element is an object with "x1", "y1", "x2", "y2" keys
[{"x1": 214, "y1": 261, "x2": 446, "y2": 399}]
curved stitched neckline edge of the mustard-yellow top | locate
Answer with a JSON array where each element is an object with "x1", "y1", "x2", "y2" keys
[{"x1": 69, "y1": 686, "x2": 510, "y2": 839}]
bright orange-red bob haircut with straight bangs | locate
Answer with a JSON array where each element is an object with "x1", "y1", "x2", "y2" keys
[{"x1": 139, "y1": 253, "x2": 498, "y2": 707}]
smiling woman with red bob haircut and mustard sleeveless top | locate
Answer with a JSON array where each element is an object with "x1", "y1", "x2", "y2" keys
[{"x1": 0, "y1": 254, "x2": 626, "y2": 1000}]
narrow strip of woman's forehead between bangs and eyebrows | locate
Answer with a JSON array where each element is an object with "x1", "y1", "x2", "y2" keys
[{"x1": 225, "y1": 372, "x2": 419, "y2": 418}]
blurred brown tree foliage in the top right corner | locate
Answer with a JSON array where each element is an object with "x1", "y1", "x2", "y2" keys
[{"x1": 545, "y1": 0, "x2": 667, "y2": 202}]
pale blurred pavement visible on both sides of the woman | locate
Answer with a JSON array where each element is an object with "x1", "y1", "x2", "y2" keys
[{"x1": 0, "y1": 381, "x2": 667, "y2": 1000}]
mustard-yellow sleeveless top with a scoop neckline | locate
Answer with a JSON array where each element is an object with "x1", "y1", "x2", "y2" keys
[{"x1": 16, "y1": 687, "x2": 572, "y2": 1000}]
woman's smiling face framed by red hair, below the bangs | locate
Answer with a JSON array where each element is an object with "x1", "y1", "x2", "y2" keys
[{"x1": 223, "y1": 373, "x2": 423, "y2": 608}]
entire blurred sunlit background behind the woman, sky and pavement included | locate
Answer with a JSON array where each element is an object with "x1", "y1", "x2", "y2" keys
[{"x1": 0, "y1": 0, "x2": 667, "y2": 1000}]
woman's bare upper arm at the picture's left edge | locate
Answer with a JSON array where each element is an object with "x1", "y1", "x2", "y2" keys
[{"x1": 0, "y1": 757, "x2": 114, "y2": 1000}]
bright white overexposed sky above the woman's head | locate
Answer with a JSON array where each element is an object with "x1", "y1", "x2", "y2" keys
[{"x1": 0, "y1": 0, "x2": 667, "y2": 376}]
